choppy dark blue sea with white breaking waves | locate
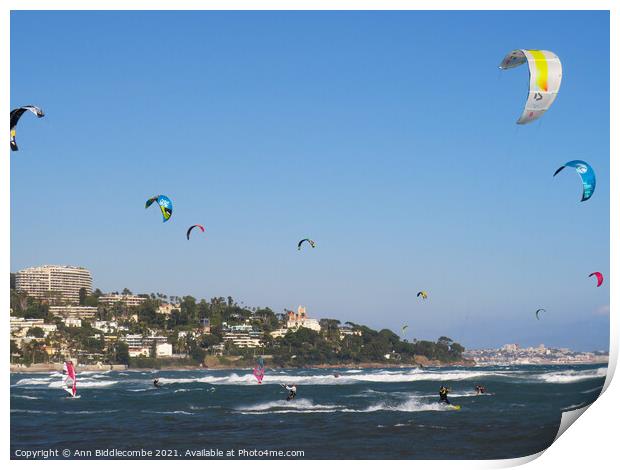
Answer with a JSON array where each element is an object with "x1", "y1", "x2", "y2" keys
[{"x1": 11, "y1": 365, "x2": 607, "y2": 459}]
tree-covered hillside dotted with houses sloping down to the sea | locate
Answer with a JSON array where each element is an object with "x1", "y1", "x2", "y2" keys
[{"x1": 10, "y1": 267, "x2": 464, "y2": 367}]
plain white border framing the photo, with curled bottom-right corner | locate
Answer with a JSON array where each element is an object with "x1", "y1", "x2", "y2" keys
[{"x1": 0, "y1": 0, "x2": 620, "y2": 469}]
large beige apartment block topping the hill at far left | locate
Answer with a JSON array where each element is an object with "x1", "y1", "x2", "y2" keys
[{"x1": 15, "y1": 265, "x2": 93, "y2": 304}]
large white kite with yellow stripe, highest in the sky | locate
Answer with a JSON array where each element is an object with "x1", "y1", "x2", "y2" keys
[{"x1": 499, "y1": 49, "x2": 562, "y2": 124}]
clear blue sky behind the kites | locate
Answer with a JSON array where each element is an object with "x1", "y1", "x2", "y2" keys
[{"x1": 10, "y1": 12, "x2": 609, "y2": 349}]
